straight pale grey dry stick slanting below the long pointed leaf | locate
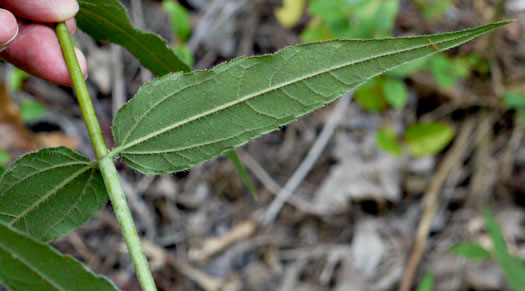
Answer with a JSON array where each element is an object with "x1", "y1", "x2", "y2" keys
[{"x1": 261, "y1": 92, "x2": 353, "y2": 225}]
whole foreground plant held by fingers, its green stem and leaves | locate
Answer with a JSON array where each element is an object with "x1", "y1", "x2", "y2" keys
[{"x1": 0, "y1": 1, "x2": 508, "y2": 290}]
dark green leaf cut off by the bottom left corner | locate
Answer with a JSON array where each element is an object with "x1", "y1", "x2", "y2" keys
[{"x1": 0, "y1": 222, "x2": 118, "y2": 291}]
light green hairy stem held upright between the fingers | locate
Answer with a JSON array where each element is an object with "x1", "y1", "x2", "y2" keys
[{"x1": 56, "y1": 23, "x2": 157, "y2": 291}]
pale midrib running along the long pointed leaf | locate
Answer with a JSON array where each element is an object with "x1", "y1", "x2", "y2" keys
[{"x1": 112, "y1": 27, "x2": 486, "y2": 155}]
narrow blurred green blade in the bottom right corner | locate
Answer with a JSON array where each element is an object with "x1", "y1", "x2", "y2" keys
[{"x1": 483, "y1": 207, "x2": 525, "y2": 291}]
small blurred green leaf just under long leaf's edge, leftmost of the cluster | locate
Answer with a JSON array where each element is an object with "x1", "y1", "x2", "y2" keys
[{"x1": 355, "y1": 77, "x2": 387, "y2": 112}]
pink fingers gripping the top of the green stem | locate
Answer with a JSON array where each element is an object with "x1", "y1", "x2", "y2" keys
[{"x1": 0, "y1": 0, "x2": 87, "y2": 86}]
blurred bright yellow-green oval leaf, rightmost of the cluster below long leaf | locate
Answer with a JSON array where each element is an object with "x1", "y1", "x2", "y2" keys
[{"x1": 404, "y1": 121, "x2": 454, "y2": 157}]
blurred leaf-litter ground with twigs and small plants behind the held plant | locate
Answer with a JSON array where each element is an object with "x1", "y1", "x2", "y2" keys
[{"x1": 0, "y1": 0, "x2": 525, "y2": 291}]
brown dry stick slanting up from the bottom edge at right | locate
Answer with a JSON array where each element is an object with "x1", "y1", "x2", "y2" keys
[{"x1": 399, "y1": 120, "x2": 476, "y2": 291}]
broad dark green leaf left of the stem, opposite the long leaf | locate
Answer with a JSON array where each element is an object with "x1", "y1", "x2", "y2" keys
[{"x1": 0, "y1": 147, "x2": 108, "y2": 242}]
